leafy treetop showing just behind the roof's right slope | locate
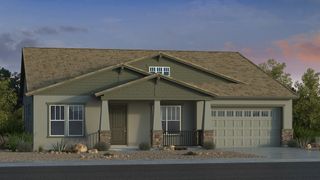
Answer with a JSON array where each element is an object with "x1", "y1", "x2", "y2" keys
[{"x1": 259, "y1": 59, "x2": 292, "y2": 89}]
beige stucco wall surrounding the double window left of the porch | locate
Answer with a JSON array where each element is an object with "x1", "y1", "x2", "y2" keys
[{"x1": 33, "y1": 95, "x2": 101, "y2": 150}]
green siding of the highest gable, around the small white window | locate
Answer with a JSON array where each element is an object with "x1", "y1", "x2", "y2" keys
[{"x1": 131, "y1": 57, "x2": 232, "y2": 83}]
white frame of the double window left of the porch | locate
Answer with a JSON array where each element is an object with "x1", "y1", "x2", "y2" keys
[{"x1": 49, "y1": 104, "x2": 85, "y2": 137}]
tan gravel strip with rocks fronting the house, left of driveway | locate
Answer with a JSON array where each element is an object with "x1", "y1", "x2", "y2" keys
[{"x1": 0, "y1": 150, "x2": 262, "y2": 163}]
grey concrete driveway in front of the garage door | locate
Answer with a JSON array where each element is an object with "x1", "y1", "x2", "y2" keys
[{"x1": 220, "y1": 147, "x2": 320, "y2": 161}]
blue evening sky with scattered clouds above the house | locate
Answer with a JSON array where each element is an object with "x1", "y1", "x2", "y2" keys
[{"x1": 0, "y1": 0, "x2": 320, "y2": 81}]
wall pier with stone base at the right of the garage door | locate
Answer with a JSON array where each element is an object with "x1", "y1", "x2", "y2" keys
[{"x1": 281, "y1": 100, "x2": 293, "y2": 146}]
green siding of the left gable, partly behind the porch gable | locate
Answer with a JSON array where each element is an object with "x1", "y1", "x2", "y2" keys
[{"x1": 39, "y1": 68, "x2": 142, "y2": 95}]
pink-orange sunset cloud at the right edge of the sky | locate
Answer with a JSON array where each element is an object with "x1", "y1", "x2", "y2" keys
[{"x1": 274, "y1": 32, "x2": 320, "y2": 62}]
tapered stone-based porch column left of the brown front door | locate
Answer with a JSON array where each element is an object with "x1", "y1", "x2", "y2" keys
[{"x1": 99, "y1": 100, "x2": 111, "y2": 143}]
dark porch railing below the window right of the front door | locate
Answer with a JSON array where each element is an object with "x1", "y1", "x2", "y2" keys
[{"x1": 163, "y1": 130, "x2": 202, "y2": 146}]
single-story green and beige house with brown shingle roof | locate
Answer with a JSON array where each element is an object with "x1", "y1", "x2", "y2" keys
[{"x1": 21, "y1": 48, "x2": 296, "y2": 149}]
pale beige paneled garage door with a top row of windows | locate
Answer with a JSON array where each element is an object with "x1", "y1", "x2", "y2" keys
[{"x1": 212, "y1": 108, "x2": 281, "y2": 148}]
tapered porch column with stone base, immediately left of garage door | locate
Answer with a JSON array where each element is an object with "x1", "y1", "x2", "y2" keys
[{"x1": 203, "y1": 101, "x2": 214, "y2": 142}]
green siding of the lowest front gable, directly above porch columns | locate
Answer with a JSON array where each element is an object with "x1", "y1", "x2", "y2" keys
[{"x1": 102, "y1": 79, "x2": 210, "y2": 100}]
